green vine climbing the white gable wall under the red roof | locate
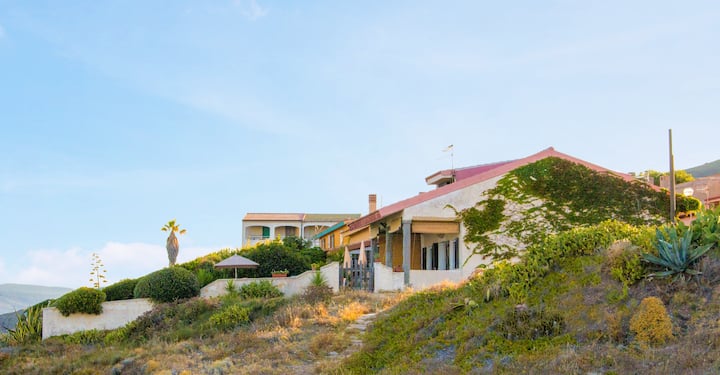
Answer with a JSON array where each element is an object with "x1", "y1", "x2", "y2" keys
[{"x1": 456, "y1": 157, "x2": 700, "y2": 260}]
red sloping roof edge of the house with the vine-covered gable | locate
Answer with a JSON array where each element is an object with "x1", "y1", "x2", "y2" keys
[{"x1": 348, "y1": 147, "x2": 636, "y2": 230}]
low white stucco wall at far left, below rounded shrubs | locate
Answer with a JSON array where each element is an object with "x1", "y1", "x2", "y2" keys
[{"x1": 43, "y1": 298, "x2": 153, "y2": 340}]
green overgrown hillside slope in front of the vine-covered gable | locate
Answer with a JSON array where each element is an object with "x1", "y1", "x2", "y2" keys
[{"x1": 342, "y1": 223, "x2": 720, "y2": 374}]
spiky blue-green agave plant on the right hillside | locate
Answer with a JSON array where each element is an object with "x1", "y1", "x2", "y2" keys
[{"x1": 643, "y1": 227, "x2": 712, "y2": 278}]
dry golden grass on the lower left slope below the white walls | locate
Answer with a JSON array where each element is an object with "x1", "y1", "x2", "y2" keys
[{"x1": 0, "y1": 292, "x2": 406, "y2": 374}]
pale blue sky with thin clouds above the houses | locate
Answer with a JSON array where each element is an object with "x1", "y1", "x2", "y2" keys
[{"x1": 0, "y1": 0, "x2": 720, "y2": 287}]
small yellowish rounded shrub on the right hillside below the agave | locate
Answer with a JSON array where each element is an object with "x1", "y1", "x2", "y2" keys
[{"x1": 630, "y1": 297, "x2": 672, "y2": 345}]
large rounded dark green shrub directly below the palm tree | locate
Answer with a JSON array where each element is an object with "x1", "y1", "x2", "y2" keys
[{"x1": 135, "y1": 267, "x2": 200, "y2": 302}]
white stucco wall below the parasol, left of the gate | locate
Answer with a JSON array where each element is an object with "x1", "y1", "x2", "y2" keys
[{"x1": 200, "y1": 262, "x2": 340, "y2": 298}]
